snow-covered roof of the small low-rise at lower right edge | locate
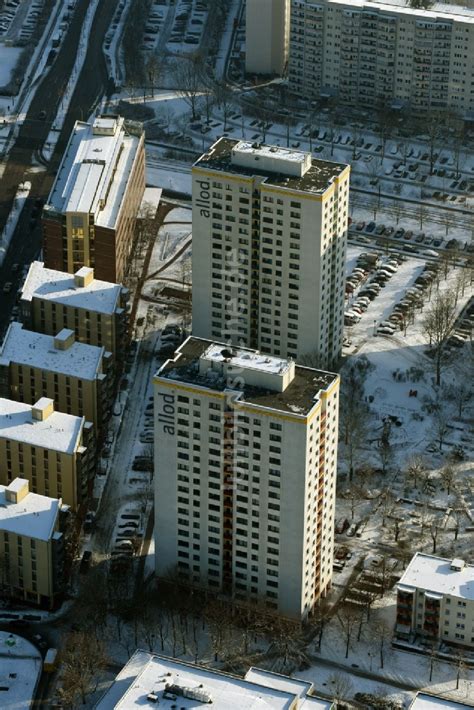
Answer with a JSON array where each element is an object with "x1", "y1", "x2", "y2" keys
[{"x1": 399, "y1": 552, "x2": 474, "y2": 600}]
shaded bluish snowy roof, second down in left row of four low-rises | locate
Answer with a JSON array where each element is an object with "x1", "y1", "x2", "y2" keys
[{"x1": 0, "y1": 323, "x2": 104, "y2": 380}]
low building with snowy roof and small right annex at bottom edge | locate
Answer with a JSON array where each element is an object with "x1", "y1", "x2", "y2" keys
[{"x1": 95, "y1": 650, "x2": 334, "y2": 710}]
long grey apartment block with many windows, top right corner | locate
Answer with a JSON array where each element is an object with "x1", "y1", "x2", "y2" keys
[{"x1": 288, "y1": 0, "x2": 474, "y2": 114}]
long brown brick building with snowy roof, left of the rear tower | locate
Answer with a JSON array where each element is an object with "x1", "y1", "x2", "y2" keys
[{"x1": 42, "y1": 116, "x2": 145, "y2": 283}]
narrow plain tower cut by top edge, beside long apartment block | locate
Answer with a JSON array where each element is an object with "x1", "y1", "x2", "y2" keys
[{"x1": 245, "y1": 0, "x2": 290, "y2": 74}]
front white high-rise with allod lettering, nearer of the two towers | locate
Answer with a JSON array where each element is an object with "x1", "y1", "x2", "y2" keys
[{"x1": 154, "y1": 337, "x2": 339, "y2": 619}]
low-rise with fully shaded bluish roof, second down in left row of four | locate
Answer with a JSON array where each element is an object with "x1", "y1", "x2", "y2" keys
[{"x1": 0, "y1": 323, "x2": 113, "y2": 434}]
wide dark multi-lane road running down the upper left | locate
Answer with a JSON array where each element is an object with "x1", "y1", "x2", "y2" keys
[{"x1": 0, "y1": 0, "x2": 115, "y2": 336}]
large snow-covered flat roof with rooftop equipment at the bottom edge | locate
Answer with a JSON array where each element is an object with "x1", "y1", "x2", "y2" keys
[{"x1": 96, "y1": 651, "x2": 309, "y2": 710}]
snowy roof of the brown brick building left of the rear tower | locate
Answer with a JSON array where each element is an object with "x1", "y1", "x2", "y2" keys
[{"x1": 46, "y1": 117, "x2": 143, "y2": 228}]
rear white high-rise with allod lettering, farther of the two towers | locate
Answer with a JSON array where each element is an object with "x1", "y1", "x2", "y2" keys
[{"x1": 193, "y1": 138, "x2": 350, "y2": 367}]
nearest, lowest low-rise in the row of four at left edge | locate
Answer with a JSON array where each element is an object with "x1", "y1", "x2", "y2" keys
[{"x1": 0, "y1": 478, "x2": 64, "y2": 608}]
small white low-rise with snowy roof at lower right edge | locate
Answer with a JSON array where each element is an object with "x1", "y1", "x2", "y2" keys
[{"x1": 396, "y1": 552, "x2": 474, "y2": 648}]
